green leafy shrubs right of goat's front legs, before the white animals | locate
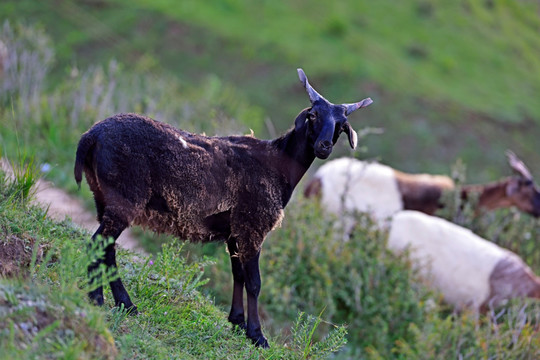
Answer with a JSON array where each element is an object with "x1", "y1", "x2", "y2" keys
[{"x1": 189, "y1": 184, "x2": 540, "y2": 359}]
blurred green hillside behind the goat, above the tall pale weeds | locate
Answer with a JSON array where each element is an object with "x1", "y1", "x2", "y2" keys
[{"x1": 4, "y1": 0, "x2": 540, "y2": 181}]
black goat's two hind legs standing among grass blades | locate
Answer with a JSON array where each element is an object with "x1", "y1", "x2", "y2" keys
[{"x1": 88, "y1": 208, "x2": 137, "y2": 314}]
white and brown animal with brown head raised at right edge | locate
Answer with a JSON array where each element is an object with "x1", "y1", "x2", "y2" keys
[{"x1": 304, "y1": 151, "x2": 540, "y2": 223}]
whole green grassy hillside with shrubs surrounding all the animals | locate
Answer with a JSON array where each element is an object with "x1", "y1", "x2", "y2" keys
[{"x1": 0, "y1": 0, "x2": 540, "y2": 359}]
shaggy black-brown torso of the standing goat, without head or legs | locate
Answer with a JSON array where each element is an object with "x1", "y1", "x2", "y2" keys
[{"x1": 75, "y1": 114, "x2": 286, "y2": 262}]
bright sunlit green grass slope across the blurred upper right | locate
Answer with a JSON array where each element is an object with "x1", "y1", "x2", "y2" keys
[{"x1": 121, "y1": 0, "x2": 540, "y2": 122}]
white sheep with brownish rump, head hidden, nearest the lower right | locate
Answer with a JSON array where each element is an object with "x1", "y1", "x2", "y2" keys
[{"x1": 388, "y1": 210, "x2": 540, "y2": 311}]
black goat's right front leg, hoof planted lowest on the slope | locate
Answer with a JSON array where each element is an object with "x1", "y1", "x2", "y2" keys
[{"x1": 244, "y1": 252, "x2": 268, "y2": 348}]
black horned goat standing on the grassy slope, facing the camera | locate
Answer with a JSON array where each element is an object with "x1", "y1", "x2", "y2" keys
[{"x1": 75, "y1": 69, "x2": 372, "y2": 347}]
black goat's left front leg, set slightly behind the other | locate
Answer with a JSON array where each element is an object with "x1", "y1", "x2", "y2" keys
[{"x1": 227, "y1": 238, "x2": 246, "y2": 330}]
